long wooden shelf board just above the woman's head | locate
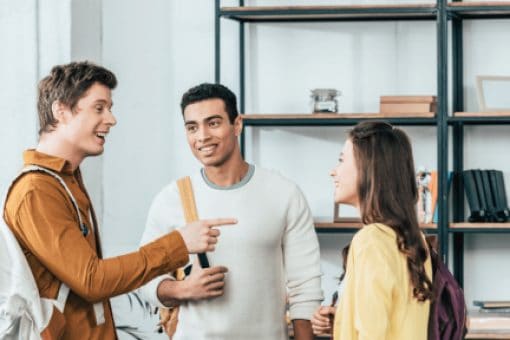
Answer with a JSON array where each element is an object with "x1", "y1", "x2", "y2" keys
[{"x1": 242, "y1": 112, "x2": 436, "y2": 120}]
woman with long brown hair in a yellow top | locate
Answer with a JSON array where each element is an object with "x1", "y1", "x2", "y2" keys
[{"x1": 312, "y1": 122, "x2": 432, "y2": 340}]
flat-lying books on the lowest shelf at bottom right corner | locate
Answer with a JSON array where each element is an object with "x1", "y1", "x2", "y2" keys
[{"x1": 468, "y1": 301, "x2": 510, "y2": 334}]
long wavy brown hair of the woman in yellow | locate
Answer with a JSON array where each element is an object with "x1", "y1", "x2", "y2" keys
[{"x1": 349, "y1": 121, "x2": 432, "y2": 301}]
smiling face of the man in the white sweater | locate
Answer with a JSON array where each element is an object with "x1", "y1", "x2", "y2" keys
[{"x1": 184, "y1": 98, "x2": 242, "y2": 167}]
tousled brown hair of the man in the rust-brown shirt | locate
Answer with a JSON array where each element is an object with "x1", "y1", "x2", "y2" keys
[{"x1": 37, "y1": 61, "x2": 117, "y2": 135}]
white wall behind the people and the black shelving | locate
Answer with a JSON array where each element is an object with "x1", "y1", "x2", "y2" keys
[{"x1": 0, "y1": 0, "x2": 510, "y2": 338}]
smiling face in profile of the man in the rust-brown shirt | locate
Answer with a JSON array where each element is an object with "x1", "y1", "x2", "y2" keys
[{"x1": 55, "y1": 82, "x2": 117, "y2": 159}]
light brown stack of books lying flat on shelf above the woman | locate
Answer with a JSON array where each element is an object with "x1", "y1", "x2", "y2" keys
[{"x1": 379, "y1": 96, "x2": 437, "y2": 117}]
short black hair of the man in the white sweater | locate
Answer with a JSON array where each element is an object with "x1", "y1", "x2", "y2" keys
[{"x1": 181, "y1": 83, "x2": 239, "y2": 123}]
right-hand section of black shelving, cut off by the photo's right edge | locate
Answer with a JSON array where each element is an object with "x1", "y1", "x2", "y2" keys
[{"x1": 446, "y1": 9, "x2": 510, "y2": 330}]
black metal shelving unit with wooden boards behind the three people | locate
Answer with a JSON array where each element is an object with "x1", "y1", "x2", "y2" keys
[{"x1": 215, "y1": 0, "x2": 510, "y2": 339}]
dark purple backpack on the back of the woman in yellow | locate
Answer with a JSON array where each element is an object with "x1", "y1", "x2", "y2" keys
[{"x1": 427, "y1": 240, "x2": 467, "y2": 340}]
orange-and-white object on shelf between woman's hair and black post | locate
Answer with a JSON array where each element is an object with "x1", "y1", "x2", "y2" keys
[{"x1": 416, "y1": 168, "x2": 437, "y2": 223}]
